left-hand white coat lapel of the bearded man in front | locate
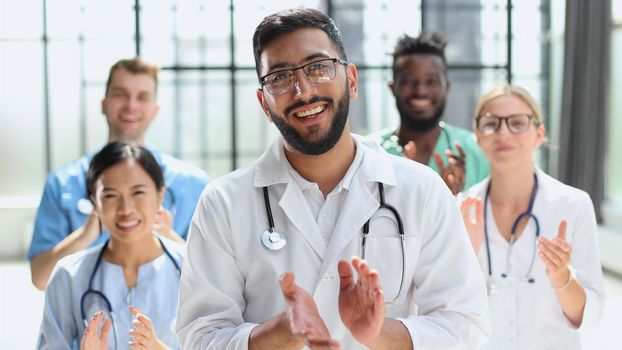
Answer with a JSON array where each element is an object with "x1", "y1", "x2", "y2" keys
[{"x1": 279, "y1": 181, "x2": 326, "y2": 257}]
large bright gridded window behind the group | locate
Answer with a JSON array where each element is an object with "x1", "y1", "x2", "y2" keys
[{"x1": 0, "y1": 0, "x2": 550, "y2": 197}]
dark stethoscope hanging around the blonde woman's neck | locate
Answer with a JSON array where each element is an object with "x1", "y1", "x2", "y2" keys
[{"x1": 484, "y1": 174, "x2": 540, "y2": 293}]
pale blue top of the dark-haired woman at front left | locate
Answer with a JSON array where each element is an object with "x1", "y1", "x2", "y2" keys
[{"x1": 36, "y1": 238, "x2": 185, "y2": 349}]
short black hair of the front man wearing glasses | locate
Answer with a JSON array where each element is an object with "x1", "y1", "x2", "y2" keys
[{"x1": 253, "y1": 8, "x2": 348, "y2": 77}]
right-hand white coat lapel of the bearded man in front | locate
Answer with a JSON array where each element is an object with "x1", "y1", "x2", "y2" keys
[{"x1": 320, "y1": 176, "x2": 379, "y2": 276}]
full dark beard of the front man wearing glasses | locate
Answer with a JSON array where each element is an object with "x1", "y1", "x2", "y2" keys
[{"x1": 269, "y1": 90, "x2": 350, "y2": 156}]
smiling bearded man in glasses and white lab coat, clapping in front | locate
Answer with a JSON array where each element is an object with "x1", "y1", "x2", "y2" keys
[{"x1": 177, "y1": 9, "x2": 490, "y2": 350}]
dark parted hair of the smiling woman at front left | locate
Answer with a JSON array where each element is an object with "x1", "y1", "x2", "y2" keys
[{"x1": 86, "y1": 141, "x2": 164, "y2": 198}]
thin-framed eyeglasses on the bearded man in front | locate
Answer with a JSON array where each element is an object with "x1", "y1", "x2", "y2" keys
[{"x1": 259, "y1": 58, "x2": 348, "y2": 95}]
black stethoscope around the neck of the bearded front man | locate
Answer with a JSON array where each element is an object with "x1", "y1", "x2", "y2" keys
[{"x1": 261, "y1": 182, "x2": 406, "y2": 304}]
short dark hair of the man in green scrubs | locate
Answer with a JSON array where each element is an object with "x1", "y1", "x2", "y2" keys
[{"x1": 393, "y1": 32, "x2": 447, "y2": 76}]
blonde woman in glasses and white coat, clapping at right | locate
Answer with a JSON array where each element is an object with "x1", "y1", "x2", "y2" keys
[{"x1": 458, "y1": 86, "x2": 604, "y2": 350}]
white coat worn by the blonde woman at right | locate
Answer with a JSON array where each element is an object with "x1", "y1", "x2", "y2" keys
[{"x1": 460, "y1": 169, "x2": 605, "y2": 350}]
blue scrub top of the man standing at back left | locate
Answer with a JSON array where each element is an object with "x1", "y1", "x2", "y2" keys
[{"x1": 28, "y1": 146, "x2": 209, "y2": 260}]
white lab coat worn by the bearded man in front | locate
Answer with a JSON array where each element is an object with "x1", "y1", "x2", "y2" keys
[{"x1": 177, "y1": 135, "x2": 490, "y2": 350}]
